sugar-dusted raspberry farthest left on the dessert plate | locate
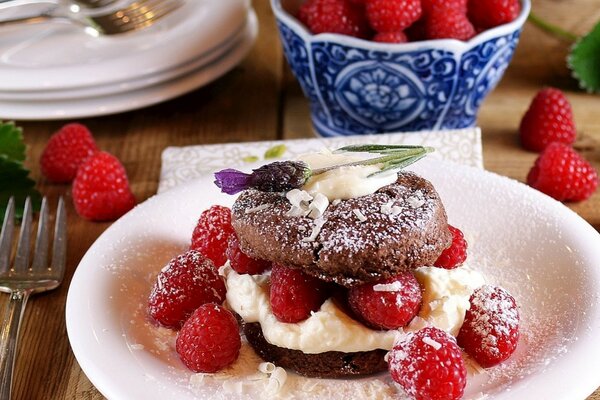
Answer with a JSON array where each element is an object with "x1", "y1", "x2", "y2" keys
[{"x1": 148, "y1": 250, "x2": 226, "y2": 328}]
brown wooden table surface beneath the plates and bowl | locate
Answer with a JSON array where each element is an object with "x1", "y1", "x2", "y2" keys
[{"x1": 2, "y1": 0, "x2": 600, "y2": 400}]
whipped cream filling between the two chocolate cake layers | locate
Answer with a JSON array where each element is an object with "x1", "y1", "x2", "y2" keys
[{"x1": 222, "y1": 267, "x2": 484, "y2": 354}]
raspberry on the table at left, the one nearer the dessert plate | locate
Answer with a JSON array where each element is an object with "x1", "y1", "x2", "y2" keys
[{"x1": 73, "y1": 151, "x2": 135, "y2": 221}]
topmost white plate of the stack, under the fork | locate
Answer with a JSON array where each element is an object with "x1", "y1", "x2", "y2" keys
[{"x1": 0, "y1": 0, "x2": 249, "y2": 91}]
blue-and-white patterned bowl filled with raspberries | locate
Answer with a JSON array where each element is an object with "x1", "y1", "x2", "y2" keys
[{"x1": 271, "y1": 0, "x2": 531, "y2": 137}]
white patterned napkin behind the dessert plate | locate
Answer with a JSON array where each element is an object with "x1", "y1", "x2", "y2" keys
[{"x1": 158, "y1": 128, "x2": 483, "y2": 193}]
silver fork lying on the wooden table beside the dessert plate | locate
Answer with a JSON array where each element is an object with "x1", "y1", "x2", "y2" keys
[{"x1": 0, "y1": 198, "x2": 67, "y2": 400}]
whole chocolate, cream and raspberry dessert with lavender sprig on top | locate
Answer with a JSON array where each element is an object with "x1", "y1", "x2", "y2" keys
[{"x1": 148, "y1": 145, "x2": 519, "y2": 399}]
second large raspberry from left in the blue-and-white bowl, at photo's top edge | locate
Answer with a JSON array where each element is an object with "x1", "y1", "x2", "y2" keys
[{"x1": 366, "y1": 0, "x2": 422, "y2": 32}]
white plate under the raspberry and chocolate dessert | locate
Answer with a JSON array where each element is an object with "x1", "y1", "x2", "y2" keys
[{"x1": 66, "y1": 159, "x2": 600, "y2": 400}]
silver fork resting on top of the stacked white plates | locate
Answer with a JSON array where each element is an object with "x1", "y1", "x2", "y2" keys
[{"x1": 0, "y1": 0, "x2": 184, "y2": 36}]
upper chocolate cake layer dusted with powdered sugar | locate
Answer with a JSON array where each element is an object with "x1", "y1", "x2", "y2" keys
[{"x1": 232, "y1": 172, "x2": 452, "y2": 287}]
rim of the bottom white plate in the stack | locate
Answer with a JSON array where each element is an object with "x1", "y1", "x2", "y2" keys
[{"x1": 0, "y1": 11, "x2": 258, "y2": 120}]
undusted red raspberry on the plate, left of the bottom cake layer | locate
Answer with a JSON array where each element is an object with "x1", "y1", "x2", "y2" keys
[{"x1": 175, "y1": 304, "x2": 242, "y2": 373}]
